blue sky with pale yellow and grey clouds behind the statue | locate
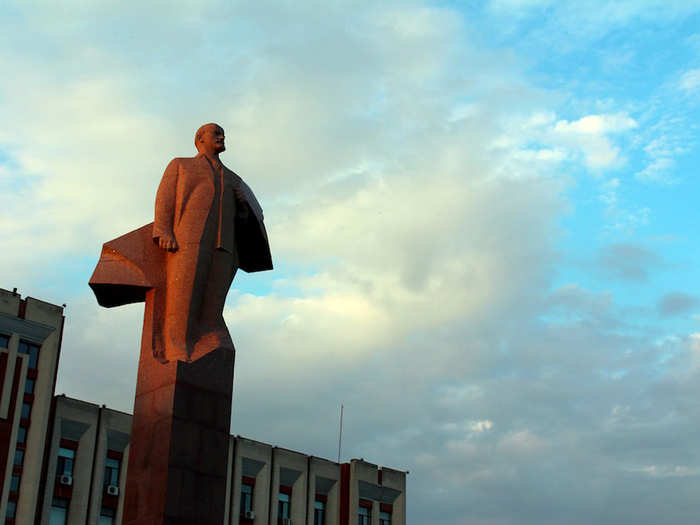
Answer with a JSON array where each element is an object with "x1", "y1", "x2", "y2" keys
[{"x1": 0, "y1": 0, "x2": 700, "y2": 525}]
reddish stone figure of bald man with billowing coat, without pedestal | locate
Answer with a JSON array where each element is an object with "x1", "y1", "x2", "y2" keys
[{"x1": 90, "y1": 124, "x2": 272, "y2": 362}]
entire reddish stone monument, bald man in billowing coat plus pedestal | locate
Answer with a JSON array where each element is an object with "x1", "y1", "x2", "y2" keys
[{"x1": 90, "y1": 124, "x2": 272, "y2": 525}]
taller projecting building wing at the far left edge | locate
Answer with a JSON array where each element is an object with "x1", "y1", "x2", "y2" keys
[{"x1": 0, "y1": 289, "x2": 64, "y2": 524}]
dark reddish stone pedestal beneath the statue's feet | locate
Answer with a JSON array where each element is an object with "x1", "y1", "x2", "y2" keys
[{"x1": 122, "y1": 348, "x2": 235, "y2": 525}]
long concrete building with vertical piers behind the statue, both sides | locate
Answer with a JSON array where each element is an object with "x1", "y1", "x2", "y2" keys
[{"x1": 0, "y1": 289, "x2": 406, "y2": 525}]
